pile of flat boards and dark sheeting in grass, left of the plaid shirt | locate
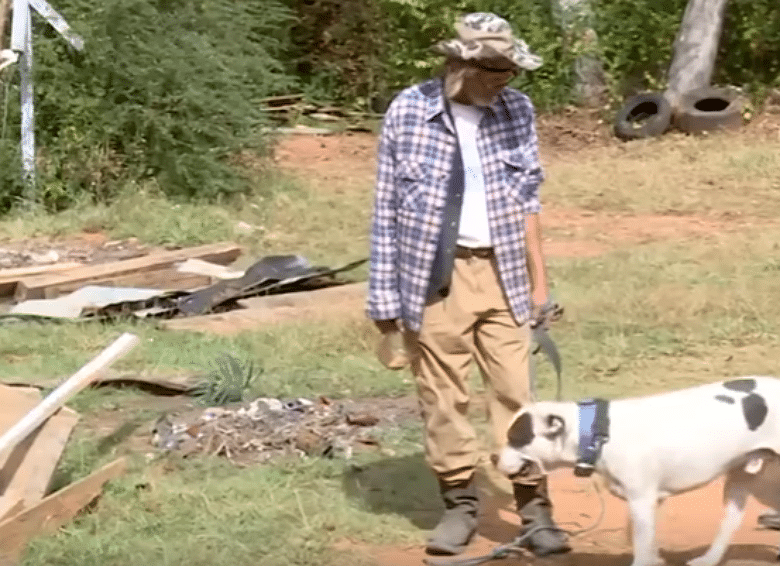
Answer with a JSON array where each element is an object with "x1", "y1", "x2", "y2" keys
[{"x1": 0, "y1": 242, "x2": 366, "y2": 328}]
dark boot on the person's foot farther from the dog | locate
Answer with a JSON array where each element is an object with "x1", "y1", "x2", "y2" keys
[{"x1": 425, "y1": 478, "x2": 478, "y2": 555}]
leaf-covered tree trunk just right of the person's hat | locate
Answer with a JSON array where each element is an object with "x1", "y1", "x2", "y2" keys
[{"x1": 552, "y1": 0, "x2": 606, "y2": 106}]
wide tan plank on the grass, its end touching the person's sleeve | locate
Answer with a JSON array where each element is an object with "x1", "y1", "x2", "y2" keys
[{"x1": 161, "y1": 284, "x2": 365, "y2": 336}]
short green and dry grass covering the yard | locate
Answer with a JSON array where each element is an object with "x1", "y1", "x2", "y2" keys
[{"x1": 0, "y1": 122, "x2": 780, "y2": 566}]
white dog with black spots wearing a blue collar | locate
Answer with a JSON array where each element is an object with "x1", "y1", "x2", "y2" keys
[{"x1": 497, "y1": 377, "x2": 780, "y2": 566}]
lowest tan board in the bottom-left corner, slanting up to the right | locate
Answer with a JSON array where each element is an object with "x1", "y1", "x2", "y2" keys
[{"x1": 0, "y1": 458, "x2": 127, "y2": 563}]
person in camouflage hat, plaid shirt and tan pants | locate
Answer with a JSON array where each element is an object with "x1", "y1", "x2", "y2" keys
[{"x1": 367, "y1": 13, "x2": 569, "y2": 556}]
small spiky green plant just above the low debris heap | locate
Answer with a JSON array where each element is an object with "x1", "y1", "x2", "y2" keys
[{"x1": 194, "y1": 354, "x2": 262, "y2": 406}]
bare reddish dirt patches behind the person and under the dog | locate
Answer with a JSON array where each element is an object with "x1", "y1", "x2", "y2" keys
[{"x1": 275, "y1": 117, "x2": 780, "y2": 566}]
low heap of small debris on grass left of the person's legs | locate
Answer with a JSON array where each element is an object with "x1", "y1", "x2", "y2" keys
[{"x1": 152, "y1": 397, "x2": 380, "y2": 464}]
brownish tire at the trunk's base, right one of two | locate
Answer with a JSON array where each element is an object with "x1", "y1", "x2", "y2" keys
[{"x1": 674, "y1": 87, "x2": 744, "y2": 134}]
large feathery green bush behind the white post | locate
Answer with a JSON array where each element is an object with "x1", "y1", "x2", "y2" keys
[{"x1": 0, "y1": 0, "x2": 296, "y2": 209}]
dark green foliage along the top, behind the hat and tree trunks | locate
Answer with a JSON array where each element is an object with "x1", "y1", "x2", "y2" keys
[{"x1": 288, "y1": 0, "x2": 780, "y2": 109}]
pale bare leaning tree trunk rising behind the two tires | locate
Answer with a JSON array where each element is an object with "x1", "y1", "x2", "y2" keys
[{"x1": 664, "y1": 0, "x2": 728, "y2": 108}]
